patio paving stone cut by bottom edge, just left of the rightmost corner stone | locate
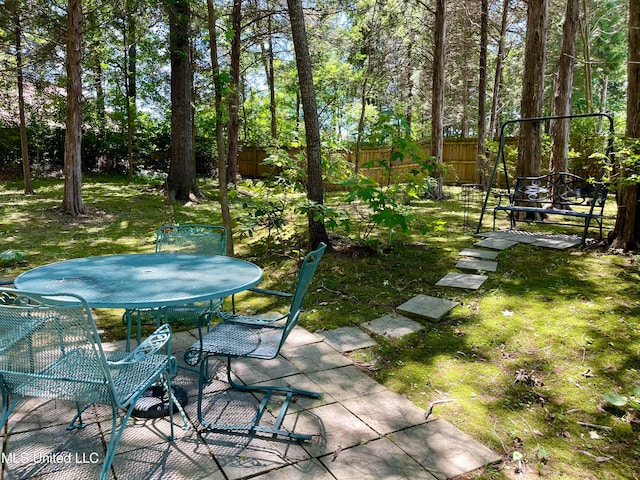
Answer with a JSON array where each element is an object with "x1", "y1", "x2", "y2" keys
[{"x1": 320, "y1": 438, "x2": 436, "y2": 480}]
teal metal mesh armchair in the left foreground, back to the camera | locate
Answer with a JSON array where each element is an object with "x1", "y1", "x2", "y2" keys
[{"x1": 0, "y1": 288, "x2": 176, "y2": 479}]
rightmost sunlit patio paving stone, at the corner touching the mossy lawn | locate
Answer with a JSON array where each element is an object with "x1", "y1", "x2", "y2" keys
[{"x1": 390, "y1": 420, "x2": 502, "y2": 480}]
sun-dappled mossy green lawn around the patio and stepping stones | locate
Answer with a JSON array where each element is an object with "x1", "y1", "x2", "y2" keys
[{"x1": 0, "y1": 177, "x2": 640, "y2": 479}]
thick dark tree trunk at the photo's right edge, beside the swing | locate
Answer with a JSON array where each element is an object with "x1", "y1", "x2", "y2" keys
[{"x1": 610, "y1": 0, "x2": 640, "y2": 250}]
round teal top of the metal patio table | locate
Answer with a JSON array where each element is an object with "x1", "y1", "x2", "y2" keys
[{"x1": 14, "y1": 253, "x2": 262, "y2": 308}]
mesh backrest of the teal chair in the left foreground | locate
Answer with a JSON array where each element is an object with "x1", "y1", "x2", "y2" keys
[{"x1": 0, "y1": 289, "x2": 115, "y2": 404}]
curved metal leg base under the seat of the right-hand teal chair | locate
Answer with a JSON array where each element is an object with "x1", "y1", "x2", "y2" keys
[{"x1": 198, "y1": 356, "x2": 323, "y2": 441}]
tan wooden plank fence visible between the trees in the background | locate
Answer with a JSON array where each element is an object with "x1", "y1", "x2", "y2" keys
[{"x1": 238, "y1": 138, "x2": 477, "y2": 185}]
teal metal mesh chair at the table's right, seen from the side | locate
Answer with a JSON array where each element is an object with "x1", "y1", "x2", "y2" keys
[{"x1": 185, "y1": 243, "x2": 326, "y2": 440}]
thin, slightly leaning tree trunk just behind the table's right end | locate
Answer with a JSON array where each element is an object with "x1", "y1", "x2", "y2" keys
[{"x1": 207, "y1": 0, "x2": 234, "y2": 257}]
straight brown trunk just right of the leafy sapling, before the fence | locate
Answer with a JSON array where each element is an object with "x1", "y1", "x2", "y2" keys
[{"x1": 431, "y1": 0, "x2": 447, "y2": 199}]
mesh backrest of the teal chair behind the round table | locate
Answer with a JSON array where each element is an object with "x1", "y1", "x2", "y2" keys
[{"x1": 156, "y1": 224, "x2": 227, "y2": 255}]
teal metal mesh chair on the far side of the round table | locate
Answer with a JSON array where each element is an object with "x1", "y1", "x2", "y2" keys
[{"x1": 123, "y1": 224, "x2": 227, "y2": 348}]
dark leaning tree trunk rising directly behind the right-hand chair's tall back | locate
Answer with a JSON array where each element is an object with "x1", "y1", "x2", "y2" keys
[{"x1": 287, "y1": 0, "x2": 329, "y2": 249}]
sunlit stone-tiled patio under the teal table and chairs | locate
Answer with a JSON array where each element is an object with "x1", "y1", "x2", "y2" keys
[{"x1": 0, "y1": 328, "x2": 501, "y2": 480}]
